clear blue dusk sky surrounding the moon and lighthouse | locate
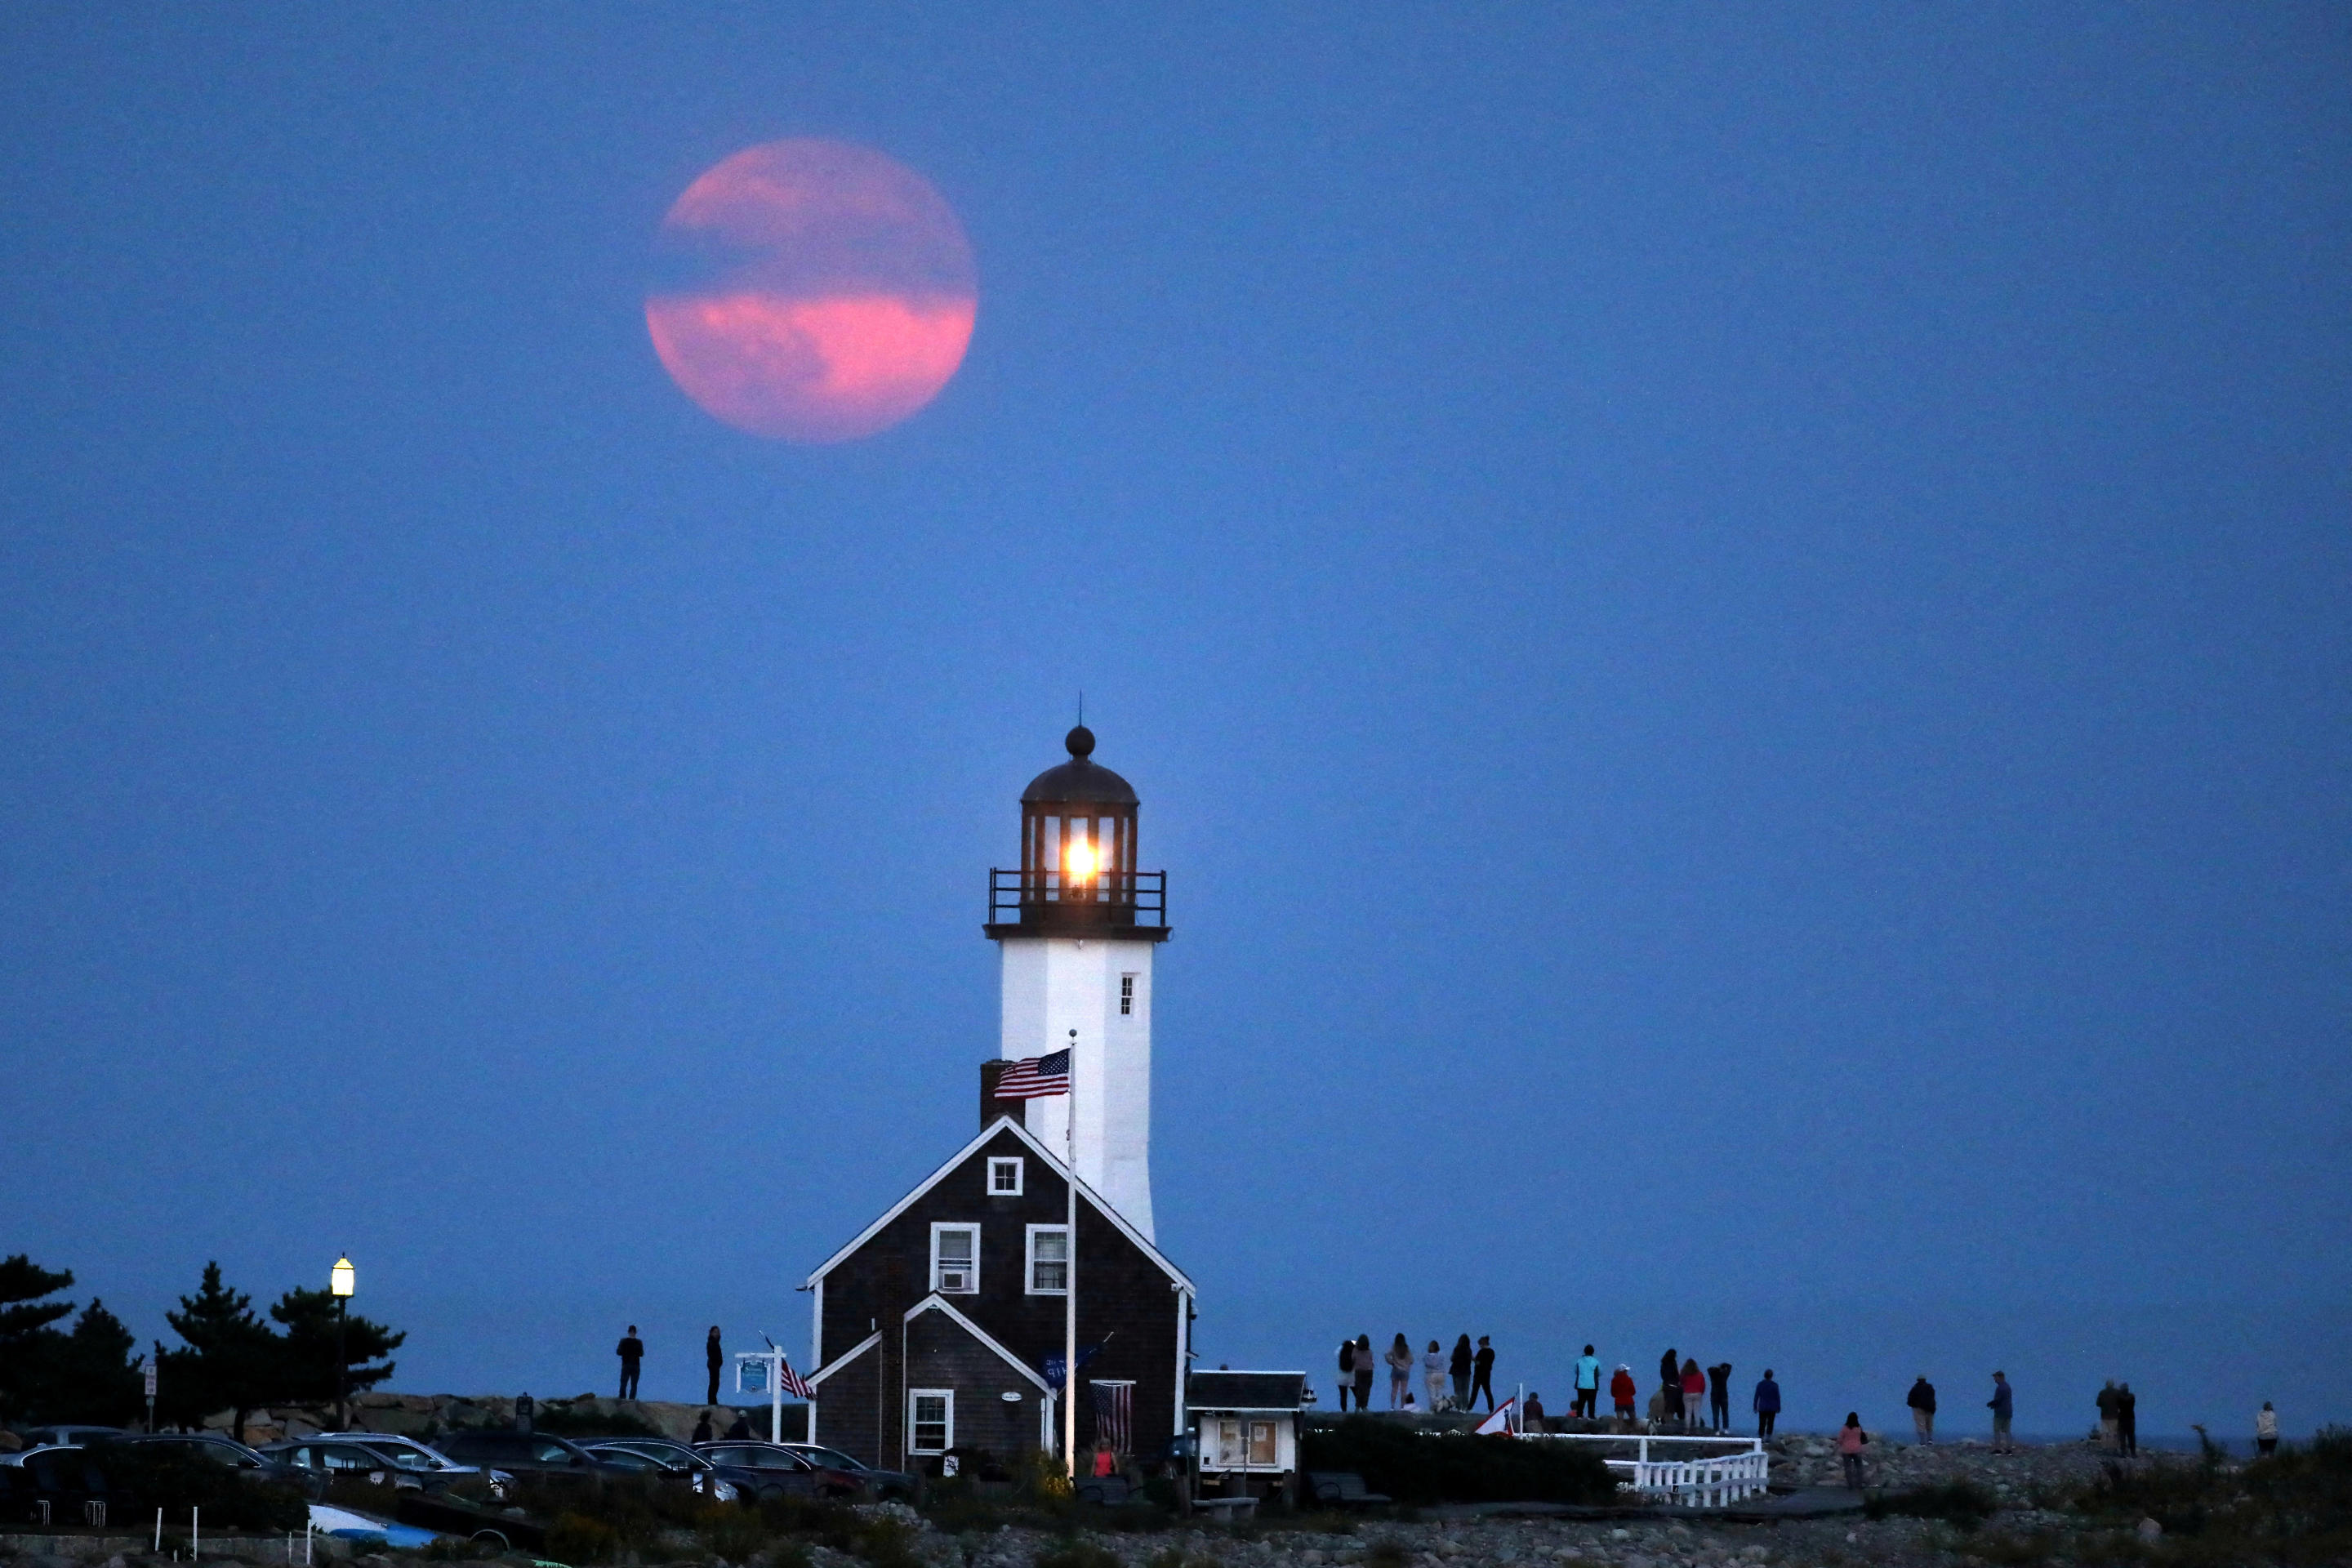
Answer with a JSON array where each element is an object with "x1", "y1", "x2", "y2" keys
[{"x1": 0, "y1": 0, "x2": 2352, "y2": 1437}]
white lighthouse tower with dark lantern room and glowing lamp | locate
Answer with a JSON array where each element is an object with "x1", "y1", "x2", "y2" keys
[{"x1": 981, "y1": 724, "x2": 1169, "y2": 1239}]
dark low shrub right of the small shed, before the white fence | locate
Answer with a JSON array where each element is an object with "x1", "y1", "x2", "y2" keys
[{"x1": 1298, "y1": 1415, "x2": 1616, "y2": 1504}]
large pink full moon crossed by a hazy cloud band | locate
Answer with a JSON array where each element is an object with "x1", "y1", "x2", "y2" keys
[{"x1": 644, "y1": 139, "x2": 981, "y2": 442}]
